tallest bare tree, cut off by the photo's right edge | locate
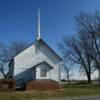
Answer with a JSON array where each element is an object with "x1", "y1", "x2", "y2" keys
[{"x1": 76, "y1": 11, "x2": 100, "y2": 80}]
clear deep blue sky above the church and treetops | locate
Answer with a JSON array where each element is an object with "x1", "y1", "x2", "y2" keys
[{"x1": 0, "y1": 0, "x2": 100, "y2": 51}]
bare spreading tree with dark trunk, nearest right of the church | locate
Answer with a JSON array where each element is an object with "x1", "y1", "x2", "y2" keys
[{"x1": 59, "y1": 34, "x2": 92, "y2": 83}]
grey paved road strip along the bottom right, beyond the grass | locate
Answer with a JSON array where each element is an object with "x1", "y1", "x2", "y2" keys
[{"x1": 48, "y1": 96, "x2": 100, "y2": 100}]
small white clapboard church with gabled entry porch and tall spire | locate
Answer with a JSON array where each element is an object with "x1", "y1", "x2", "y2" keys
[{"x1": 9, "y1": 11, "x2": 62, "y2": 86}]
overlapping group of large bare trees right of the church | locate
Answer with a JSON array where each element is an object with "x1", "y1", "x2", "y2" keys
[{"x1": 58, "y1": 11, "x2": 100, "y2": 83}]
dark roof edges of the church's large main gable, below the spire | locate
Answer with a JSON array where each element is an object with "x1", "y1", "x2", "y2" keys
[{"x1": 12, "y1": 39, "x2": 62, "y2": 61}]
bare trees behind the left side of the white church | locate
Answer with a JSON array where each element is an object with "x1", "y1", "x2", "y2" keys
[{"x1": 0, "y1": 40, "x2": 29, "y2": 78}]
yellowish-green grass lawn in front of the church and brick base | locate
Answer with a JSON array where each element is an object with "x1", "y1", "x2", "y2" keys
[{"x1": 0, "y1": 85, "x2": 100, "y2": 100}]
